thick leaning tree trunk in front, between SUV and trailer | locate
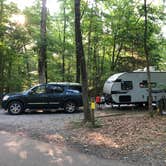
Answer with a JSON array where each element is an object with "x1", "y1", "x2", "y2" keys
[{"x1": 75, "y1": 0, "x2": 91, "y2": 122}]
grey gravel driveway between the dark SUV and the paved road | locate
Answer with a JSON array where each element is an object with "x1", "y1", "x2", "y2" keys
[{"x1": 0, "y1": 109, "x2": 83, "y2": 139}]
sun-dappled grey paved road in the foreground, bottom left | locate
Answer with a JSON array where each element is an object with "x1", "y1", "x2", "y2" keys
[{"x1": 0, "y1": 131, "x2": 132, "y2": 166}]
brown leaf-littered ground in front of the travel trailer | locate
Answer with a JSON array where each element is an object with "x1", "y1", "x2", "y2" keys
[{"x1": 63, "y1": 107, "x2": 166, "y2": 166}]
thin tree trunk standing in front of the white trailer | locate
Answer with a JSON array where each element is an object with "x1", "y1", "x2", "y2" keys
[{"x1": 144, "y1": 0, "x2": 152, "y2": 111}]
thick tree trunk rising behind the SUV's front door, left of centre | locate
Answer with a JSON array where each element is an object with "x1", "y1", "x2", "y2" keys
[{"x1": 38, "y1": 0, "x2": 47, "y2": 83}]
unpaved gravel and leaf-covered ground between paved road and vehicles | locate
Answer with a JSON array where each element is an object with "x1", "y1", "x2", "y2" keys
[{"x1": 0, "y1": 109, "x2": 166, "y2": 166}]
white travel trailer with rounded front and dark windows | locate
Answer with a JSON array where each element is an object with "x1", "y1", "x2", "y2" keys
[{"x1": 103, "y1": 70, "x2": 166, "y2": 105}]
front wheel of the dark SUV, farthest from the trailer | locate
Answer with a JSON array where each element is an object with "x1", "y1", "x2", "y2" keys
[{"x1": 8, "y1": 101, "x2": 23, "y2": 115}]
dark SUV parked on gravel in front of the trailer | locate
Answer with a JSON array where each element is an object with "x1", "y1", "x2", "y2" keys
[{"x1": 2, "y1": 83, "x2": 82, "y2": 115}]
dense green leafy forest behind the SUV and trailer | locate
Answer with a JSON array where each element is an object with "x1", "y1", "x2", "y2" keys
[{"x1": 0, "y1": 0, "x2": 166, "y2": 94}]
